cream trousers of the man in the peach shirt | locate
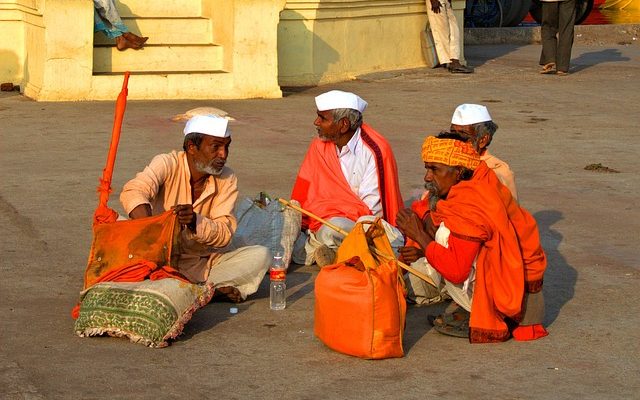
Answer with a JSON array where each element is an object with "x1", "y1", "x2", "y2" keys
[{"x1": 207, "y1": 246, "x2": 272, "y2": 300}]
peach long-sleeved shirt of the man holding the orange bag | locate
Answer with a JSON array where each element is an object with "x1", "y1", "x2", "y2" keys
[{"x1": 120, "y1": 151, "x2": 238, "y2": 282}]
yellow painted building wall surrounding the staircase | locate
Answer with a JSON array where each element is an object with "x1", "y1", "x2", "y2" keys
[{"x1": 0, "y1": 0, "x2": 464, "y2": 101}]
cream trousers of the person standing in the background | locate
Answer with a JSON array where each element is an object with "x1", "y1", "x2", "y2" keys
[{"x1": 426, "y1": 0, "x2": 460, "y2": 64}]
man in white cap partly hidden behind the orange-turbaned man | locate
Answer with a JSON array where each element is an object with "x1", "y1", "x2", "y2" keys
[{"x1": 450, "y1": 104, "x2": 518, "y2": 200}]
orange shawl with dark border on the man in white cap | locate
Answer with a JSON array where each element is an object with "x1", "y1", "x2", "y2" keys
[{"x1": 291, "y1": 124, "x2": 402, "y2": 232}]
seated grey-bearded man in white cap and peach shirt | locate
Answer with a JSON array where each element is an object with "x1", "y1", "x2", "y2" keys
[{"x1": 120, "y1": 115, "x2": 271, "y2": 302}]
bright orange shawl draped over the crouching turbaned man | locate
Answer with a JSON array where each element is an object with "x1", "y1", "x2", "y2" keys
[{"x1": 431, "y1": 162, "x2": 547, "y2": 343}]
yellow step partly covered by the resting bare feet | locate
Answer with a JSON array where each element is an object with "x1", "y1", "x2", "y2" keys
[{"x1": 93, "y1": 17, "x2": 211, "y2": 45}]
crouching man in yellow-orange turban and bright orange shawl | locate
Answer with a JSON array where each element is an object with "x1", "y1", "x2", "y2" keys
[{"x1": 397, "y1": 133, "x2": 547, "y2": 343}]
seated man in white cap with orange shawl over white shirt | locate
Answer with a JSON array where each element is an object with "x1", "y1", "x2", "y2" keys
[{"x1": 291, "y1": 90, "x2": 403, "y2": 266}]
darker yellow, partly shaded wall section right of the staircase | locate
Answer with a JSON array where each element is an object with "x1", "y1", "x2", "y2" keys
[{"x1": 278, "y1": 0, "x2": 427, "y2": 86}]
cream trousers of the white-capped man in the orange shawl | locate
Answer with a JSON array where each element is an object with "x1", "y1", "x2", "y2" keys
[{"x1": 294, "y1": 215, "x2": 404, "y2": 265}]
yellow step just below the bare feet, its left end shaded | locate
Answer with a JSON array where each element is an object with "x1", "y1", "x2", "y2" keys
[{"x1": 93, "y1": 45, "x2": 223, "y2": 74}]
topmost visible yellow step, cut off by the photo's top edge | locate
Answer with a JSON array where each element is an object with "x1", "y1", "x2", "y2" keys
[{"x1": 116, "y1": 0, "x2": 202, "y2": 18}]
